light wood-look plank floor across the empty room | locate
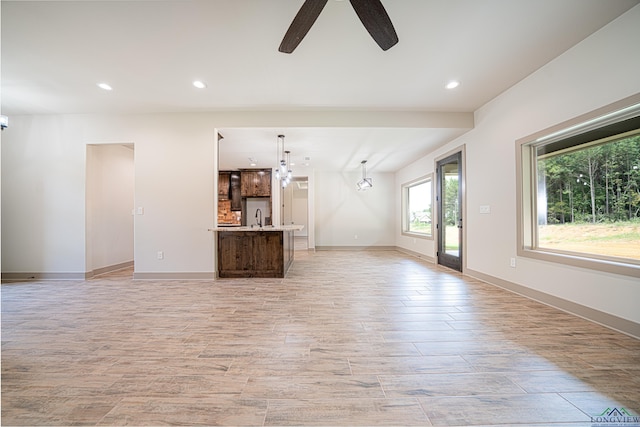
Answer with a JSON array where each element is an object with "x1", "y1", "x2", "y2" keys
[{"x1": 2, "y1": 251, "x2": 640, "y2": 426}]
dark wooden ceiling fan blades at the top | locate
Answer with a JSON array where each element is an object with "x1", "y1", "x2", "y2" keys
[{"x1": 278, "y1": 0, "x2": 398, "y2": 53}]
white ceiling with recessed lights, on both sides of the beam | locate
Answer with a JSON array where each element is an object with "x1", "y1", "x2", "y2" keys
[{"x1": 1, "y1": 0, "x2": 639, "y2": 171}]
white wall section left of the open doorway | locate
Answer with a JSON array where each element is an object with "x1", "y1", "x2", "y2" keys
[{"x1": 2, "y1": 116, "x2": 86, "y2": 278}]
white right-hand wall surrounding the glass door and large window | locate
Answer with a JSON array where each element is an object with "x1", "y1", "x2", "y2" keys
[{"x1": 396, "y1": 6, "x2": 640, "y2": 323}]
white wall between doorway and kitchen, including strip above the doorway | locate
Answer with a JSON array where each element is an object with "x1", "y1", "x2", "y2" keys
[{"x1": 85, "y1": 114, "x2": 217, "y2": 278}]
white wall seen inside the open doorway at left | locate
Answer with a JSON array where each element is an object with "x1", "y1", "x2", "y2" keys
[{"x1": 86, "y1": 144, "x2": 135, "y2": 272}]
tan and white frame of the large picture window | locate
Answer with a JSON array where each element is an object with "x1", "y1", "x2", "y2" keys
[{"x1": 516, "y1": 94, "x2": 640, "y2": 277}]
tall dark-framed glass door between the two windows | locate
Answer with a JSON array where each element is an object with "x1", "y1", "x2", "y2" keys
[{"x1": 436, "y1": 152, "x2": 462, "y2": 271}]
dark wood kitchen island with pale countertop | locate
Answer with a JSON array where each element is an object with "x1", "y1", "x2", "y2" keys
[{"x1": 214, "y1": 225, "x2": 303, "y2": 278}]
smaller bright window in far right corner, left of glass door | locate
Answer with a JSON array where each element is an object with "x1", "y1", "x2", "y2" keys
[{"x1": 402, "y1": 177, "x2": 433, "y2": 237}]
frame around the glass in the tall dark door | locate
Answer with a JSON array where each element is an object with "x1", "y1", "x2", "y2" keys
[{"x1": 434, "y1": 145, "x2": 467, "y2": 272}]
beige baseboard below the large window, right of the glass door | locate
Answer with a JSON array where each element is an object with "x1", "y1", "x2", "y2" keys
[{"x1": 465, "y1": 269, "x2": 640, "y2": 339}]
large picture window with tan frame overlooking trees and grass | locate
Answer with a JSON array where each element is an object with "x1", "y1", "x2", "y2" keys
[{"x1": 518, "y1": 96, "x2": 640, "y2": 277}]
